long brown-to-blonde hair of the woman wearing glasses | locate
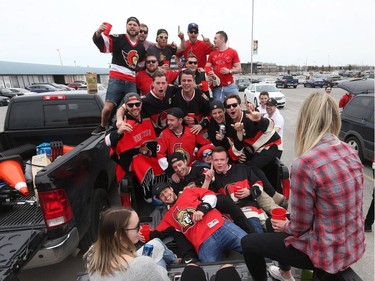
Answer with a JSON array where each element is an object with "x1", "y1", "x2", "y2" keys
[{"x1": 83, "y1": 207, "x2": 136, "y2": 276}]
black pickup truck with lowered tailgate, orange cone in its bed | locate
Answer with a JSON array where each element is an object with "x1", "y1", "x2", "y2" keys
[{"x1": 0, "y1": 93, "x2": 117, "y2": 280}]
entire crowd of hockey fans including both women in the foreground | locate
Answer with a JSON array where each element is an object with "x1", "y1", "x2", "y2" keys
[{"x1": 85, "y1": 17, "x2": 365, "y2": 281}]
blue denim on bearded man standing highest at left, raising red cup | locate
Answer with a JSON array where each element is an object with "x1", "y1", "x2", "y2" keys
[{"x1": 105, "y1": 78, "x2": 137, "y2": 107}]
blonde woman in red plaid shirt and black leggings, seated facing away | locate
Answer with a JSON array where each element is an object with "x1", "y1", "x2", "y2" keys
[{"x1": 242, "y1": 93, "x2": 365, "y2": 281}]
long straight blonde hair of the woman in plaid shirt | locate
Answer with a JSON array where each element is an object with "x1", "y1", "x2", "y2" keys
[{"x1": 295, "y1": 93, "x2": 341, "y2": 157}]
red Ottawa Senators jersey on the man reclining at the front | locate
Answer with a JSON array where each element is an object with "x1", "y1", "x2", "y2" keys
[{"x1": 155, "y1": 188, "x2": 224, "y2": 250}]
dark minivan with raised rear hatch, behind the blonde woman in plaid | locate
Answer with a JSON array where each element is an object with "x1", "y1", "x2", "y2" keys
[{"x1": 338, "y1": 79, "x2": 374, "y2": 161}]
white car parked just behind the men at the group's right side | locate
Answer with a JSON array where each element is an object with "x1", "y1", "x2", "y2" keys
[{"x1": 244, "y1": 83, "x2": 285, "y2": 108}]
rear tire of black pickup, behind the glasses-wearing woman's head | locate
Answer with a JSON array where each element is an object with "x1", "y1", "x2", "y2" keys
[{"x1": 79, "y1": 188, "x2": 109, "y2": 251}]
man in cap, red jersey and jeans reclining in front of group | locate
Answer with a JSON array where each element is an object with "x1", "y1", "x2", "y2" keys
[{"x1": 153, "y1": 183, "x2": 246, "y2": 262}]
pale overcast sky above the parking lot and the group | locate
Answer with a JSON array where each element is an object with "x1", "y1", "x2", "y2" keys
[{"x1": 0, "y1": 0, "x2": 375, "y2": 67}]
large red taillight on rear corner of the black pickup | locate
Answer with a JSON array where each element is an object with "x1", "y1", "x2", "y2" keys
[{"x1": 38, "y1": 189, "x2": 73, "y2": 228}]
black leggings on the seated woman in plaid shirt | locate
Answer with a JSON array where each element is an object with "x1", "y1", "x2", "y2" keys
[{"x1": 241, "y1": 232, "x2": 315, "y2": 281}]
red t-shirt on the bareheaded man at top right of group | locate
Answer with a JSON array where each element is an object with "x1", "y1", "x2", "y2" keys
[{"x1": 208, "y1": 48, "x2": 240, "y2": 87}]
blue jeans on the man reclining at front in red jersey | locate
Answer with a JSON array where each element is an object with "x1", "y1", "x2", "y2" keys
[{"x1": 198, "y1": 220, "x2": 246, "y2": 262}]
